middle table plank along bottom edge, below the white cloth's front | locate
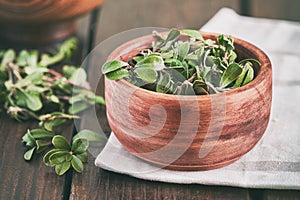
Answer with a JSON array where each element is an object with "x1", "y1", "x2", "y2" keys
[{"x1": 70, "y1": 105, "x2": 248, "y2": 200}]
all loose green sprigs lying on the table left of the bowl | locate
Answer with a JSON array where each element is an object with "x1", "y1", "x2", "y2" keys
[{"x1": 0, "y1": 38, "x2": 105, "y2": 175}]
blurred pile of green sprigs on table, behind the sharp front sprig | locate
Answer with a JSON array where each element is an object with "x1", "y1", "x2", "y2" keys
[{"x1": 0, "y1": 38, "x2": 104, "y2": 121}]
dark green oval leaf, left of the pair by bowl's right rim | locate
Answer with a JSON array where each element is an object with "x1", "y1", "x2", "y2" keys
[{"x1": 220, "y1": 63, "x2": 243, "y2": 88}]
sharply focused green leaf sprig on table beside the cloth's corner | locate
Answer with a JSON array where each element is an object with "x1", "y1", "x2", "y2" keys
[{"x1": 22, "y1": 123, "x2": 106, "y2": 175}]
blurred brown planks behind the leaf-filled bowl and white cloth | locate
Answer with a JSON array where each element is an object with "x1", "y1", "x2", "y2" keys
[{"x1": 87, "y1": 0, "x2": 300, "y2": 44}]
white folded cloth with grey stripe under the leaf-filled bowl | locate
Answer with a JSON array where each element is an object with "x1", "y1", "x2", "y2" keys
[{"x1": 95, "y1": 8, "x2": 300, "y2": 189}]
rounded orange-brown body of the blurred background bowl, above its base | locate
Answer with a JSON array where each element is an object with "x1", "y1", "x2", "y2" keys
[{"x1": 0, "y1": 0, "x2": 104, "y2": 24}]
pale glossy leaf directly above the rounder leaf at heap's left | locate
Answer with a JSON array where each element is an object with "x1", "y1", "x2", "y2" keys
[{"x1": 135, "y1": 55, "x2": 165, "y2": 71}]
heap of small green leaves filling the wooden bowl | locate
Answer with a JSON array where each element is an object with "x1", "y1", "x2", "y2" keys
[{"x1": 102, "y1": 29, "x2": 259, "y2": 95}]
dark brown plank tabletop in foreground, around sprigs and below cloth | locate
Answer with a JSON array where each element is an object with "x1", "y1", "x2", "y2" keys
[{"x1": 0, "y1": 105, "x2": 300, "y2": 200}]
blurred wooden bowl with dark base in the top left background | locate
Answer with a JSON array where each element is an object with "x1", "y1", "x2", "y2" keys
[{"x1": 0, "y1": 0, "x2": 104, "y2": 44}]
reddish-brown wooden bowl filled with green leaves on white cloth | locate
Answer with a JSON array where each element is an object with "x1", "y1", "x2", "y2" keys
[{"x1": 105, "y1": 33, "x2": 272, "y2": 170}]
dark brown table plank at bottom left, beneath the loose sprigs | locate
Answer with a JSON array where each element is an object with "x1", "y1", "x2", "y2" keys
[{"x1": 0, "y1": 116, "x2": 72, "y2": 199}]
